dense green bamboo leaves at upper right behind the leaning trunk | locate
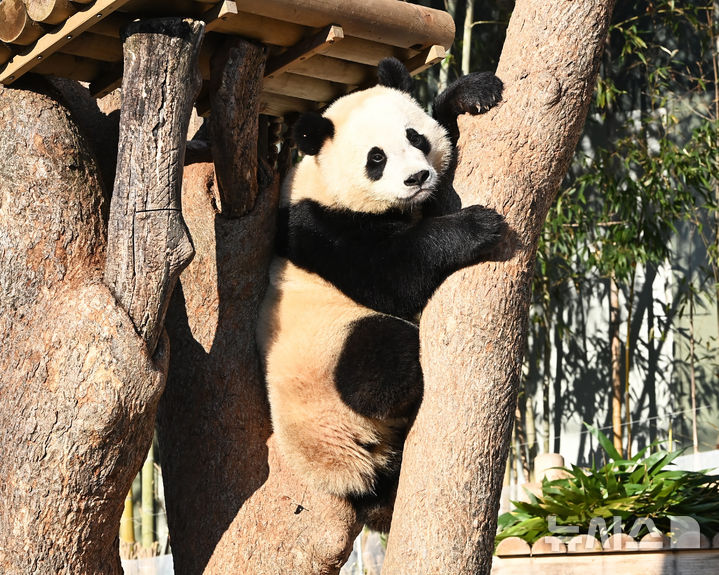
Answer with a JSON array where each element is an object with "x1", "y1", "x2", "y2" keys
[{"x1": 537, "y1": 0, "x2": 719, "y2": 289}]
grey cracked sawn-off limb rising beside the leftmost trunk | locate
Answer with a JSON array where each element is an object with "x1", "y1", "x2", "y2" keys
[{"x1": 105, "y1": 18, "x2": 204, "y2": 353}]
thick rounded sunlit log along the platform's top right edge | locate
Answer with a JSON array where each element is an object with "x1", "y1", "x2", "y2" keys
[{"x1": 225, "y1": 0, "x2": 454, "y2": 50}]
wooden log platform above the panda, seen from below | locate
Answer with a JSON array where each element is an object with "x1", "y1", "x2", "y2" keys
[{"x1": 0, "y1": 0, "x2": 454, "y2": 116}]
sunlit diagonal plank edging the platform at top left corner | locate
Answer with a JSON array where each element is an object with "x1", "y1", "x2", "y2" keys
[{"x1": 0, "y1": 0, "x2": 136, "y2": 84}]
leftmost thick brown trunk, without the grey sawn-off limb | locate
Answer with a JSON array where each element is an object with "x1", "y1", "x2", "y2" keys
[{"x1": 0, "y1": 81, "x2": 167, "y2": 575}]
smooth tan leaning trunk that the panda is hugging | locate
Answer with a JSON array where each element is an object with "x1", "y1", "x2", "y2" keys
[{"x1": 382, "y1": 0, "x2": 613, "y2": 575}]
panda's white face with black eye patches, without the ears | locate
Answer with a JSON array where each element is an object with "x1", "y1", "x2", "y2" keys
[{"x1": 293, "y1": 86, "x2": 451, "y2": 213}]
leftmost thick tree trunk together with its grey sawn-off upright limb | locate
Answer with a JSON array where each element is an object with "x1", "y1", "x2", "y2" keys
[{"x1": 0, "y1": 15, "x2": 202, "y2": 575}]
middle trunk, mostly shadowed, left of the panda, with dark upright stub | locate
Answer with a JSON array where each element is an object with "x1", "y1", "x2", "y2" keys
[{"x1": 158, "y1": 37, "x2": 360, "y2": 575}]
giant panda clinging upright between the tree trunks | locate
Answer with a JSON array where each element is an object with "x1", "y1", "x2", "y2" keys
[{"x1": 257, "y1": 59, "x2": 502, "y2": 531}]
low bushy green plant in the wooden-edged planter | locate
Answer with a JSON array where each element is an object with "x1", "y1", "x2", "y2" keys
[{"x1": 496, "y1": 427, "x2": 719, "y2": 544}]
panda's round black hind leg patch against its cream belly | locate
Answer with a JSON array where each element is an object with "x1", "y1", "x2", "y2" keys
[{"x1": 334, "y1": 314, "x2": 423, "y2": 419}]
